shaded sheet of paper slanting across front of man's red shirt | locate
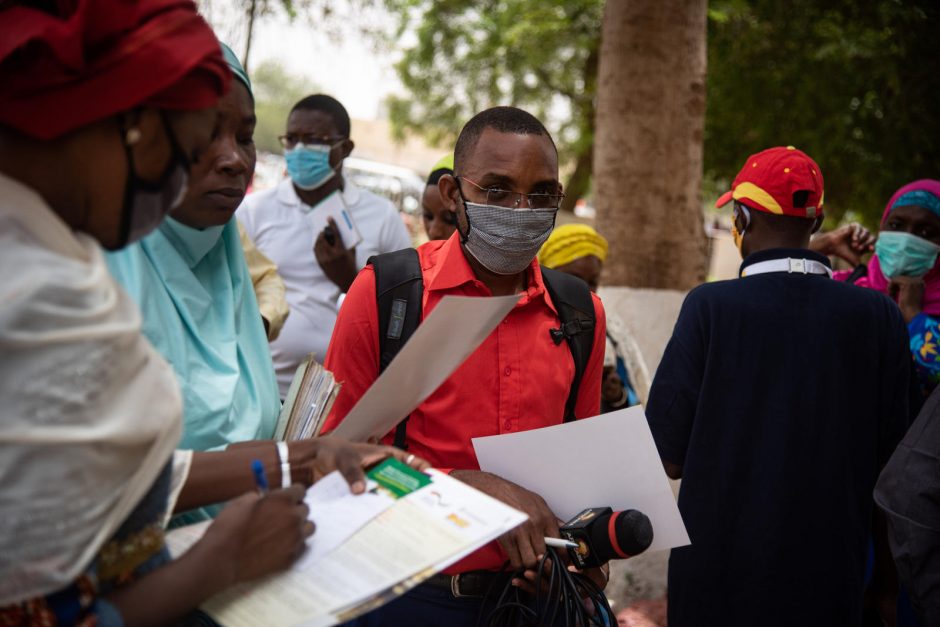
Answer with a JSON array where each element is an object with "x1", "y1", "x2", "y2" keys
[{"x1": 334, "y1": 294, "x2": 522, "y2": 441}]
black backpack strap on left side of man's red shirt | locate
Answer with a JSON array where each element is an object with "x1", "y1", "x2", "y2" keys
[{"x1": 368, "y1": 248, "x2": 424, "y2": 449}]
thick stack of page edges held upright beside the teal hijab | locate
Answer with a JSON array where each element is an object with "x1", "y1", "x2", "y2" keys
[{"x1": 274, "y1": 354, "x2": 341, "y2": 441}]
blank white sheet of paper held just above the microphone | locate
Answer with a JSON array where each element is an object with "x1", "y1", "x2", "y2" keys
[{"x1": 473, "y1": 406, "x2": 689, "y2": 551}]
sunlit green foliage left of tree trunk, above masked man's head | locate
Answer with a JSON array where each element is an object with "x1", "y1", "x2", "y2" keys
[{"x1": 385, "y1": 0, "x2": 603, "y2": 160}]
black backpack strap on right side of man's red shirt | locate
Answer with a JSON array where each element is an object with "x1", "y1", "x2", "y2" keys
[{"x1": 542, "y1": 266, "x2": 597, "y2": 422}]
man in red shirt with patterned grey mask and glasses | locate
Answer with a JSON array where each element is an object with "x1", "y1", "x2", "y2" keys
[{"x1": 325, "y1": 107, "x2": 606, "y2": 626}]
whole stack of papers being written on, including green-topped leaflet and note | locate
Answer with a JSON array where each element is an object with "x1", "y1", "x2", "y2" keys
[{"x1": 167, "y1": 460, "x2": 527, "y2": 627}]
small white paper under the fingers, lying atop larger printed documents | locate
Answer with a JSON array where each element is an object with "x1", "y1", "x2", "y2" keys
[{"x1": 292, "y1": 470, "x2": 395, "y2": 571}]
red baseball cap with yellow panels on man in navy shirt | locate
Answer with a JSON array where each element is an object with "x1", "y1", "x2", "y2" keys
[{"x1": 715, "y1": 146, "x2": 825, "y2": 218}]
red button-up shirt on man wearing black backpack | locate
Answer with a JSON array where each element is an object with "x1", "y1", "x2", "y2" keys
[{"x1": 324, "y1": 234, "x2": 606, "y2": 573}]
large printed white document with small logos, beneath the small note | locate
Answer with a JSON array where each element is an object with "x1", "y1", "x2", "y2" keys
[{"x1": 190, "y1": 471, "x2": 526, "y2": 627}]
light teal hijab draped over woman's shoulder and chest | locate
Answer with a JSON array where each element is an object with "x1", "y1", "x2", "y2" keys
[{"x1": 107, "y1": 217, "x2": 280, "y2": 520}]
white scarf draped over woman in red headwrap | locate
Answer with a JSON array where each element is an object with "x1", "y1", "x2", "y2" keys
[{"x1": 0, "y1": 174, "x2": 181, "y2": 606}]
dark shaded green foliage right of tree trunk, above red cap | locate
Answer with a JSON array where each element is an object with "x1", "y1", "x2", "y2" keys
[{"x1": 705, "y1": 0, "x2": 940, "y2": 227}]
